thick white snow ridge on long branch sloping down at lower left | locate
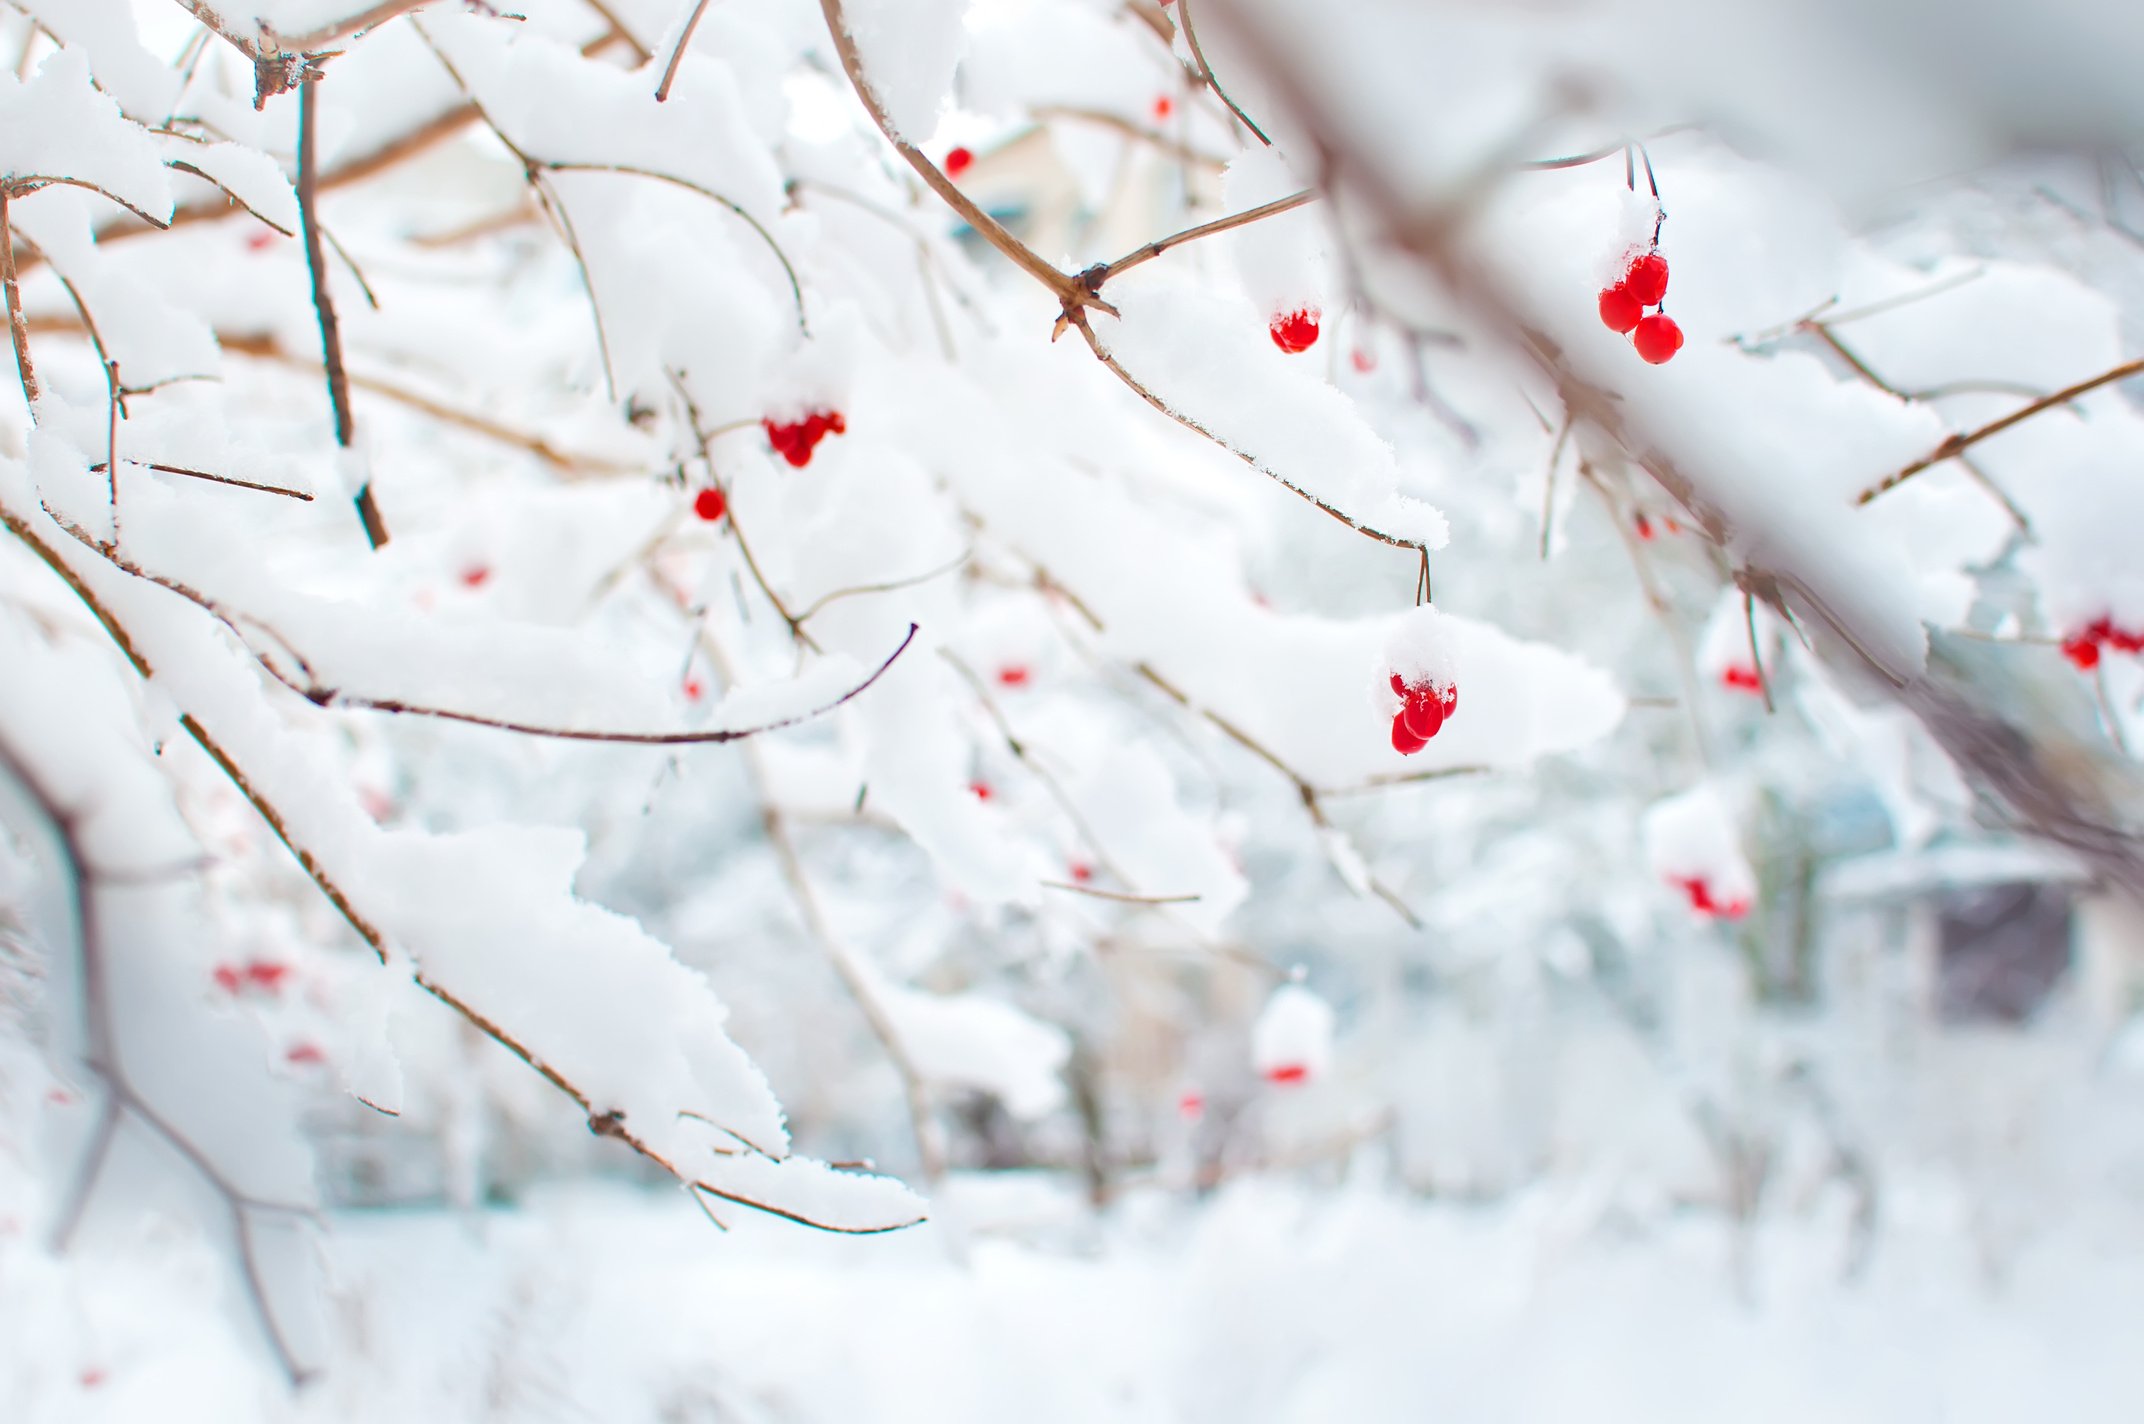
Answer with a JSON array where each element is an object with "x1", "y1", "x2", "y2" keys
[{"x1": 0, "y1": 461, "x2": 922, "y2": 1231}]
